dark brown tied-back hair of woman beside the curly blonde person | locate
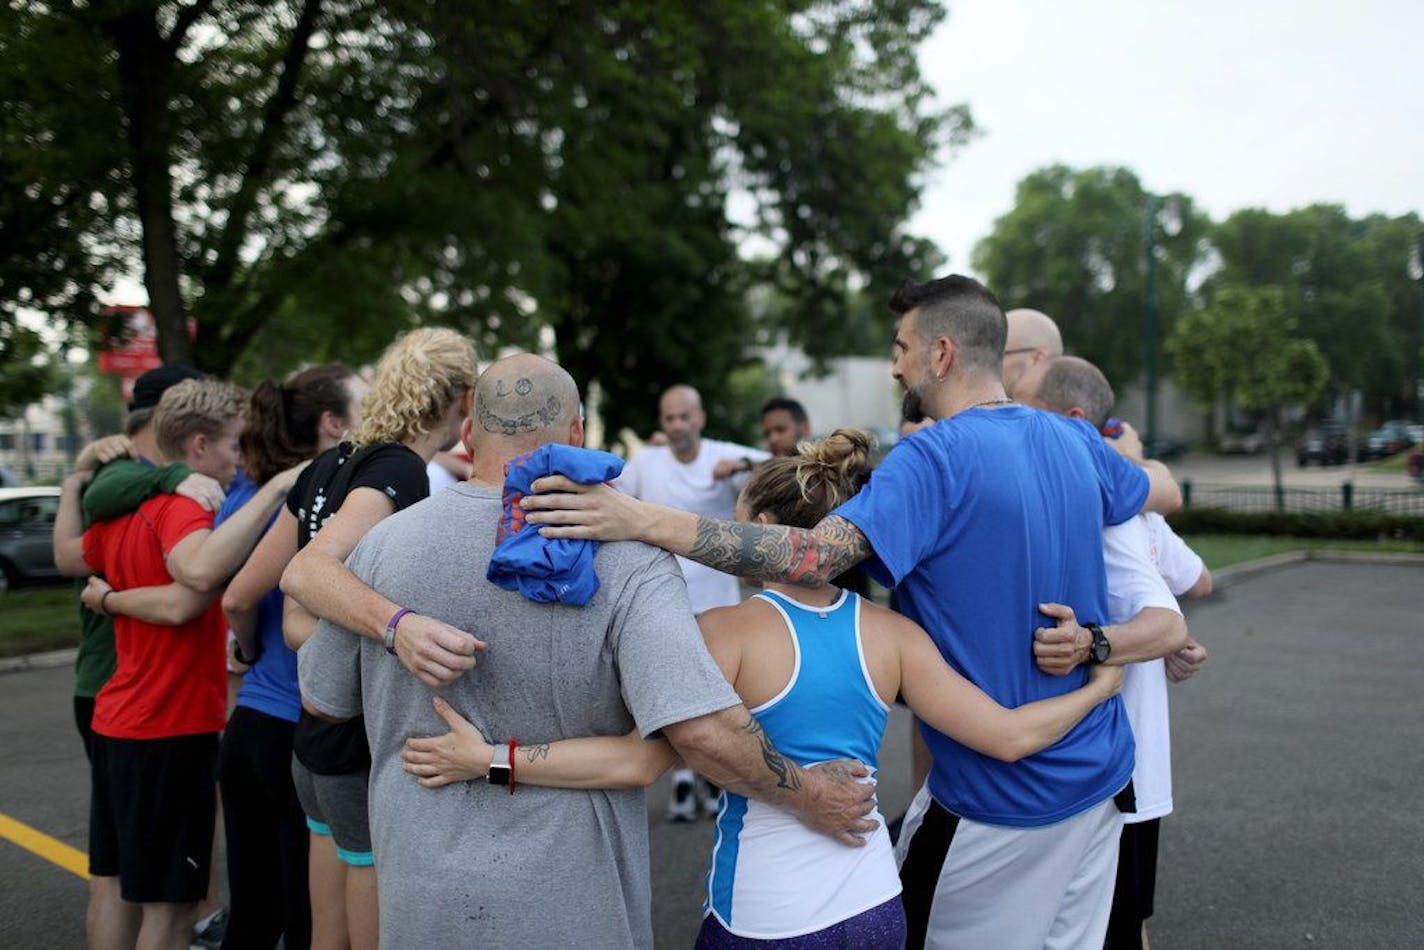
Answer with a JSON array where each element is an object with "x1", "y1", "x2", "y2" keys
[{"x1": 239, "y1": 363, "x2": 355, "y2": 484}]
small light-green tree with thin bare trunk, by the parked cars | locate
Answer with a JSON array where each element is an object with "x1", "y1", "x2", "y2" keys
[{"x1": 1166, "y1": 288, "x2": 1330, "y2": 510}]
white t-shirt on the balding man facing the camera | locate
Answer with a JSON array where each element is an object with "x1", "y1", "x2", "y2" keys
[{"x1": 614, "y1": 439, "x2": 769, "y2": 614}]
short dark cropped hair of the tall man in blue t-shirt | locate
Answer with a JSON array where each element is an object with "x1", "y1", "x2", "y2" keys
[{"x1": 890, "y1": 273, "x2": 1008, "y2": 375}]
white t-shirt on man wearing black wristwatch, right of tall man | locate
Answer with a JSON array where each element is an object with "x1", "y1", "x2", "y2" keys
[{"x1": 1102, "y1": 516, "x2": 1195, "y2": 825}]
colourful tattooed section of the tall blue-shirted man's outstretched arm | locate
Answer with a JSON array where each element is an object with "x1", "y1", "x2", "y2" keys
[{"x1": 688, "y1": 514, "x2": 870, "y2": 587}]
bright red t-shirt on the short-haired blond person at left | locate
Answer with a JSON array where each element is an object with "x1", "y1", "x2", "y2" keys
[{"x1": 84, "y1": 494, "x2": 228, "y2": 739}]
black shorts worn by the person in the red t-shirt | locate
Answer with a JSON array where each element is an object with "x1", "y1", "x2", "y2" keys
[{"x1": 90, "y1": 732, "x2": 218, "y2": 903}]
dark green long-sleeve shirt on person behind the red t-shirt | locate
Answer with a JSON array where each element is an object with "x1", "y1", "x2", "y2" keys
[{"x1": 74, "y1": 459, "x2": 192, "y2": 698}]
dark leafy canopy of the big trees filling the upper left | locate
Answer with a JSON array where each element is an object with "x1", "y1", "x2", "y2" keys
[{"x1": 0, "y1": 0, "x2": 971, "y2": 441}]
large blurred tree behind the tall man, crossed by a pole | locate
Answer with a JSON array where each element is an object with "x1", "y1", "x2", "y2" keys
[{"x1": 974, "y1": 165, "x2": 1209, "y2": 385}]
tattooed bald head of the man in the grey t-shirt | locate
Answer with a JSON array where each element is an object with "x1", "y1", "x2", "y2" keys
[{"x1": 468, "y1": 353, "x2": 584, "y2": 459}]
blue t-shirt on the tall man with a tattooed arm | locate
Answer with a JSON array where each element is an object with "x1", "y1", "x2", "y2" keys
[{"x1": 834, "y1": 406, "x2": 1148, "y2": 828}]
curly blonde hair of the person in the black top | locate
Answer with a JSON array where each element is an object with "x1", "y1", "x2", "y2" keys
[{"x1": 350, "y1": 328, "x2": 478, "y2": 446}]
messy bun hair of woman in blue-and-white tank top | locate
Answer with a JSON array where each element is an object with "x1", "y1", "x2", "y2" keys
[{"x1": 742, "y1": 429, "x2": 874, "y2": 528}]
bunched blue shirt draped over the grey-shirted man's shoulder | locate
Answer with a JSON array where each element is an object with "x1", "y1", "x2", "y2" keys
[{"x1": 484, "y1": 444, "x2": 624, "y2": 607}]
